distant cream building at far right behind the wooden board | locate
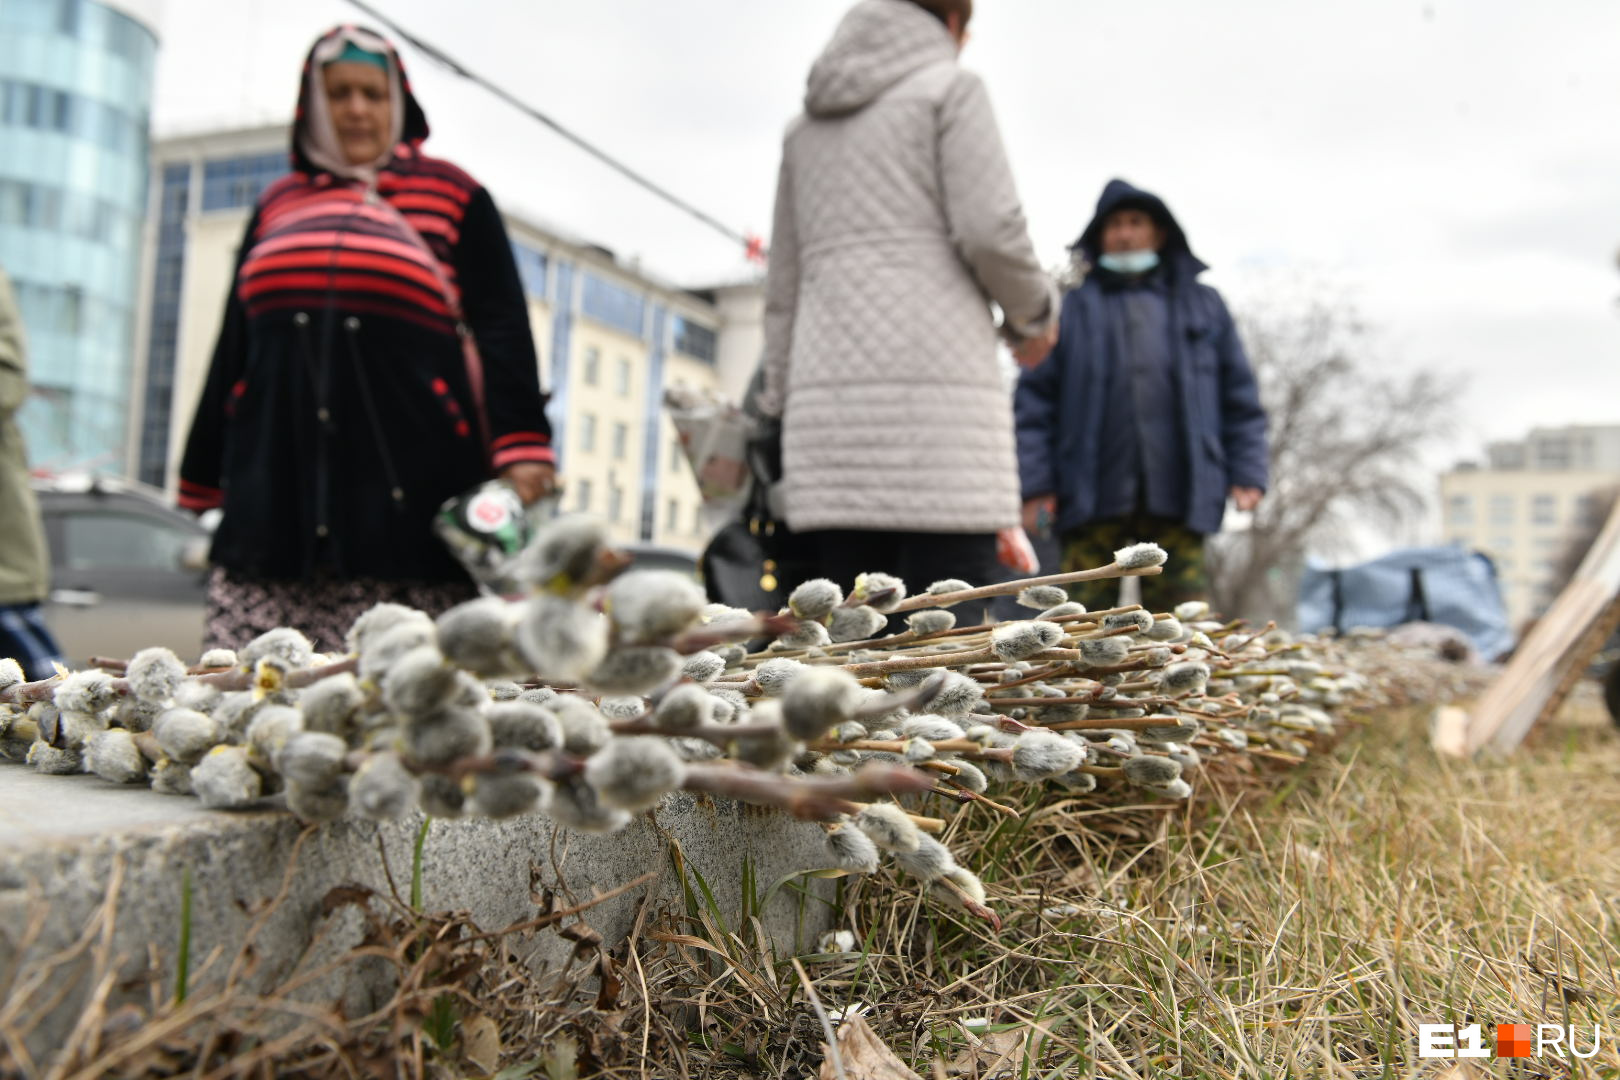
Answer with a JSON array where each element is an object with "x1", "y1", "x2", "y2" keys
[{"x1": 1440, "y1": 426, "x2": 1620, "y2": 628}]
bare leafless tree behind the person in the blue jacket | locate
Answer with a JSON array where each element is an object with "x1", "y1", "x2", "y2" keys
[{"x1": 1207, "y1": 295, "x2": 1455, "y2": 622}]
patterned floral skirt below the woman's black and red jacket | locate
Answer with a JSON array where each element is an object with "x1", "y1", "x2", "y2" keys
[{"x1": 204, "y1": 567, "x2": 478, "y2": 654}]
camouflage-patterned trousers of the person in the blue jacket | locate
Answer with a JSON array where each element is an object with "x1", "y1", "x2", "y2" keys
[{"x1": 1063, "y1": 513, "x2": 1209, "y2": 612}]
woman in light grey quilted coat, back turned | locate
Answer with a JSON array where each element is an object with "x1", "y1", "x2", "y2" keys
[{"x1": 761, "y1": 0, "x2": 1058, "y2": 617}]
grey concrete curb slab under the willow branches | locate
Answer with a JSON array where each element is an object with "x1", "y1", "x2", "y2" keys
[{"x1": 0, "y1": 764, "x2": 834, "y2": 1056}]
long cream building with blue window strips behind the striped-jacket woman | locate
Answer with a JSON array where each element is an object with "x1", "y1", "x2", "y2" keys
[{"x1": 130, "y1": 125, "x2": 763, "y2": 551}]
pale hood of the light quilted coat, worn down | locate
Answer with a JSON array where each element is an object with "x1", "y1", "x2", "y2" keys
[{"x1": 805, "y1": 0, "x2": 956, "y2": 117}]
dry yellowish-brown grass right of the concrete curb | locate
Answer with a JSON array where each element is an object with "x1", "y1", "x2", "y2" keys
[{"x1": 650, "y1": 695, "x2": 1620, "y2": 1077}]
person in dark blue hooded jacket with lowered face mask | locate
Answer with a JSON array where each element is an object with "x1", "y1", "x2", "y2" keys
[{"x1": 1016, "y1": 180, "x2": 1267, "y2": 610}]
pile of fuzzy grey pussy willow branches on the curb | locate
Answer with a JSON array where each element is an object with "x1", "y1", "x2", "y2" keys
[{"x1": 0, "y1": 517, "x2": 1366, "y2": 921}]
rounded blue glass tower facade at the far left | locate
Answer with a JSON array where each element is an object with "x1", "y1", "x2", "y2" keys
[{"x1": 0, "y1": 0, "x2": 157, "y2": 473}]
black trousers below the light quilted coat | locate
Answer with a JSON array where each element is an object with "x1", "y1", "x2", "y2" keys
[{"x1": 800, "y1": 529, "x2": 1003, "y2": 633}]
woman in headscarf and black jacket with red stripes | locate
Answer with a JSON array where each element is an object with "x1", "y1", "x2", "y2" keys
[{"x1": 180, "y1": 26, "x2": 554, "y2": 651}]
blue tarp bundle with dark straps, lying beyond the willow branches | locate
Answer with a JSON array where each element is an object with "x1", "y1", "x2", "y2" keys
[{"x1": 1298, "y1": 547, "x2": 1513, "y2": 659}]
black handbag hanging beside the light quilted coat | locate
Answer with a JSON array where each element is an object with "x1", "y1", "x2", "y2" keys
[{"x1": 698, "y1": 421, "x2": 792, "y2": 610}]
